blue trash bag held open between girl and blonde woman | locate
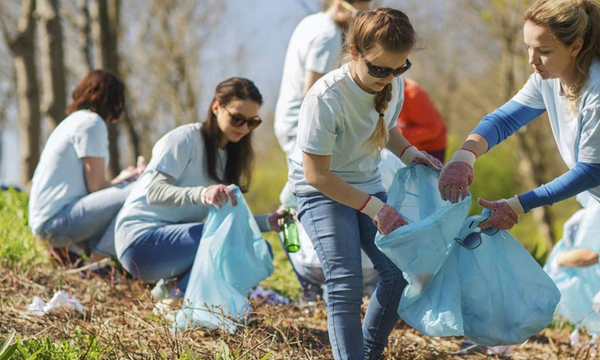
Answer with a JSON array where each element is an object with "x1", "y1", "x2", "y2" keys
[{"x1": 375, "y1": 165, "x2": 560, "y2": 346}]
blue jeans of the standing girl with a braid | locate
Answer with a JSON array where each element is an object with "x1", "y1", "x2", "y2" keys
[{"x1": 297, "y1": 193, "x2": 407, "y2": 360}]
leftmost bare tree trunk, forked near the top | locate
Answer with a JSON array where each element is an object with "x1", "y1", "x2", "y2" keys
[{"x1": 0, "y1": 0, "x2": 41, "y2": 185}]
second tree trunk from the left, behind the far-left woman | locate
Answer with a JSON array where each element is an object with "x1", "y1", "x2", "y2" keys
[{"x1": 36, "y1": 0, "x2": 67, "y2": 127}]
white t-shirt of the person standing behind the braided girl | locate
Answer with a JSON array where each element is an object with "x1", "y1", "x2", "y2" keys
[{"x1": 275, "y1": 12, "x2": 342, "y2": 155}]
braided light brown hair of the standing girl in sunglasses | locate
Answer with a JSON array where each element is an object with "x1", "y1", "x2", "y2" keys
[{"x1": 345, "y1": 8, "x2": 416, "y2": 157}]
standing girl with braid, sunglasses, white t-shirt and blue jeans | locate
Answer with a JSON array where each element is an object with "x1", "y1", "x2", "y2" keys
[{"x1": 289, "y1": 9, "x2": 441, "y2": 360}]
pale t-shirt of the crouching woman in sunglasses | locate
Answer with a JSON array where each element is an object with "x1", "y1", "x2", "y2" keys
[{"x1": 115, "y1": 123, "x2": 227, "y2": 257}]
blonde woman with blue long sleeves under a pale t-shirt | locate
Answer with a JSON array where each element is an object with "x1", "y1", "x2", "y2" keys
[{"x1": 439, "y1": 0, "x2": 600, "y2": 233}]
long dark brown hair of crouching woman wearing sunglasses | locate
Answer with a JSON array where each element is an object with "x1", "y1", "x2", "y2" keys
[{"x1": 201, "y1": 77, "x2": 263, "y2": 192}]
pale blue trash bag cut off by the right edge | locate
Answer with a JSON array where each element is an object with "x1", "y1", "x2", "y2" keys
[{"x1": 544, "y1": 196, "x2": 600, "y2": 334}]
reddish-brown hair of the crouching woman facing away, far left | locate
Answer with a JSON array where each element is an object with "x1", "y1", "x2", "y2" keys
[{"x1": 67, "y1": 70, "x2": 125, "y2": 123}]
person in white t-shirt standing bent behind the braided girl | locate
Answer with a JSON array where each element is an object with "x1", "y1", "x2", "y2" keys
[{"x1": 275, "y1": 0, "x2": 377, "y2": 304}]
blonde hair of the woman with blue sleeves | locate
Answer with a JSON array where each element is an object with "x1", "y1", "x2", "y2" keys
[{"x1": 524, "y1": 0, "x2": 600, "y2": 110}]
